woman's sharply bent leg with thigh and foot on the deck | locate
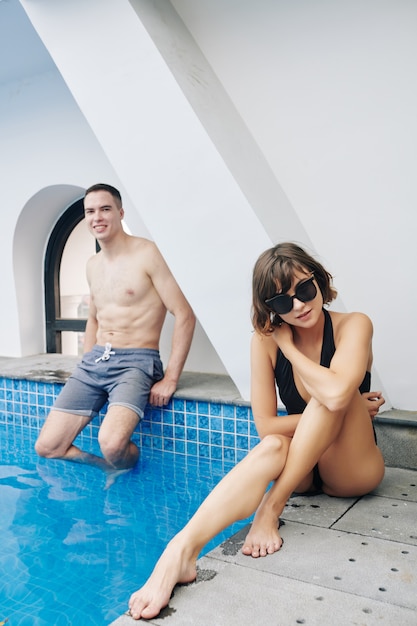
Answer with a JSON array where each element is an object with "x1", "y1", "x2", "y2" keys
[{"x1": 242, "y1": 393, "x2": 384, "y2": 557}]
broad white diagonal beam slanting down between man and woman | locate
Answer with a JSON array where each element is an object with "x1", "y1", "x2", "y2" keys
[{"x1": 22, "y1": 0, "x2": 271, "y2": 397}]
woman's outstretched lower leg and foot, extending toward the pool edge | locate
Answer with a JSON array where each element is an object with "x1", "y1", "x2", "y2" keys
[{"x1": 129, "y1": 435, "x2": 290, "y2": 619}]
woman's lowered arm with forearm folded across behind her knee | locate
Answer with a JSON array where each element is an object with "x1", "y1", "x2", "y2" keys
[{"x1": 251, "y1": 332, "x2": 300, "y2": 439}]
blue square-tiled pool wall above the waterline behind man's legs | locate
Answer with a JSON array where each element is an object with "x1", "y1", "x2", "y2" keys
[{"x1": 0, "y1": 378, "x2": 259, "y2": 463}]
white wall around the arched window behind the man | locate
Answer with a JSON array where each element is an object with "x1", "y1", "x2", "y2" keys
[{"x1": 0, "y1": 51, "x2": 225, "y2": 373}]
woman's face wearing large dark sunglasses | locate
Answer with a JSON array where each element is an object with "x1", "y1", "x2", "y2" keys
[{"x1": 271, "y1": 269, "x2": 323, "y2": 328}]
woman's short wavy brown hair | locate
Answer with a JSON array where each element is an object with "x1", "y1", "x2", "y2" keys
[{"x1": 252, "y1": 242, "x2": 337, "y2": 335}]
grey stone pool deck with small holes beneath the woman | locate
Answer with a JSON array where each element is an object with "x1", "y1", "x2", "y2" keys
[{"x1": 111, "y1": 468, "x2": 417, "y2": 626}]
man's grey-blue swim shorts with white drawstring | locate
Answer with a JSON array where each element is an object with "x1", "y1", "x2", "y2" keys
[{"x1": 53, "y1": 344, "x2": 164, "y2": 419}]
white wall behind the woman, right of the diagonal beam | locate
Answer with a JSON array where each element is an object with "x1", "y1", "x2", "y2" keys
[{"x1": 172, "y1": 0, "x2": 417, "y2": 410}]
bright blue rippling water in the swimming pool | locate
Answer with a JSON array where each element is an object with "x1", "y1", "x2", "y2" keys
[{"x1": 0, "y1": 425, "x2": 249, "y2": 626}]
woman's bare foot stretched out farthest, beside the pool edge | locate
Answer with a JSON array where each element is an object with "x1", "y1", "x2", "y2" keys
[{"x1": 129, "y1": 538, "x2": 197, "y2": 619}]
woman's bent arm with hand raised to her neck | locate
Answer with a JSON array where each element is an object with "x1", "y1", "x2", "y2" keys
[{"x1": 274, "y1": 313, "x2": 372, "y2": 411}]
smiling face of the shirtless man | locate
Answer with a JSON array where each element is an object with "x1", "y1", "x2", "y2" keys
[{"x1": 84, "y1": 191, "x2": 124, "y2": 241}]
